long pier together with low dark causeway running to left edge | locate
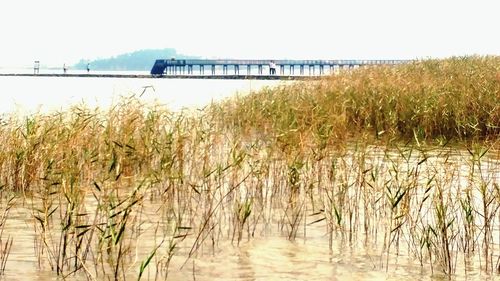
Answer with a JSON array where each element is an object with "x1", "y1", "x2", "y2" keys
[{"x1": 0, "y1": 59, "x2": 411, "y2": 80}]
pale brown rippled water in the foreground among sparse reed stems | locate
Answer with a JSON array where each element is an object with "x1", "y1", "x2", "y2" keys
[{"x1": 3, "y1": 149, "x2": 500, "y2": 280}]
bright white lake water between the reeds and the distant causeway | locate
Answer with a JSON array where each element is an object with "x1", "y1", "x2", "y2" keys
[{"x1": 0, "y1": 71, "x2": 291, "y2": 114}]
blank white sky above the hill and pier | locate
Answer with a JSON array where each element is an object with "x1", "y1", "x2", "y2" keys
[{"x1": 0, "y1": 0, "x2": 500, "y2": 67}]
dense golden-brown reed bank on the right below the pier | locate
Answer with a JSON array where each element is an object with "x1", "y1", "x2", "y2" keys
[{"x1": 213, "y1": 57, "x2": 500, "y2": 147}]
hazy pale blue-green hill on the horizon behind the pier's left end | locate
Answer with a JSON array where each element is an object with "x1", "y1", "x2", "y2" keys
[{"x1": 73, "y1": 48, "x2": 199, "y2": 70}]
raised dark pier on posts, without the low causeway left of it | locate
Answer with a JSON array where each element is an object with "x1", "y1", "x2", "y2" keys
[{"x1": 151, "y1": 59, "x2": 410, "y2": 76}]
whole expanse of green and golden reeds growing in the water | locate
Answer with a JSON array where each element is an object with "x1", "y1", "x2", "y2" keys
[{"x1": 0, "y1": 57, "x2": 500, "y2": 280}]
